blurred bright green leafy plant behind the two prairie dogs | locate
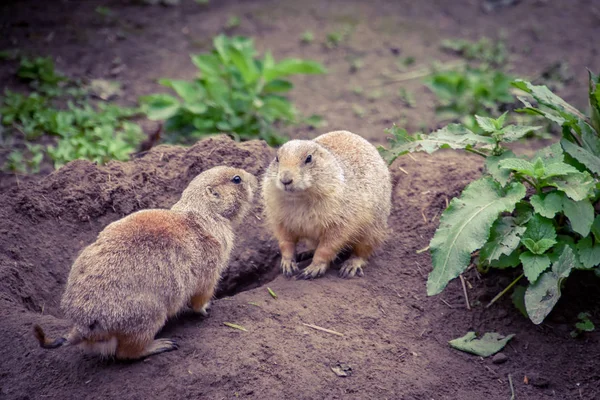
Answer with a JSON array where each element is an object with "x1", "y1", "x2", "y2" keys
[{"x1": 140, "y1": 35, "x2": 326, "y2": 144}]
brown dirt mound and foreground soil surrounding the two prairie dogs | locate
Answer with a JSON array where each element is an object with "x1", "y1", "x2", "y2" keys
[{"x1": 0, "y1": 137, "x2": 600, "y2": 399}]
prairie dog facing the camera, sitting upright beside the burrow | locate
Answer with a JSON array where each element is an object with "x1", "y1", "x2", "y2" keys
[{"x1": 262, "y1": 131, "x2": 392, "y2": 279}]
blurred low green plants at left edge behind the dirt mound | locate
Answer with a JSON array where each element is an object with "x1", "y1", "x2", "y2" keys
[{"x1": 0, "y1": 58, "x2": 143, "y2": 173}]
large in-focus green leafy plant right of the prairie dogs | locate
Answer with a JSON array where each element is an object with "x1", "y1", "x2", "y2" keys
[{"x1": 381, "y1": 73, "x2": 600, "y2": 324}]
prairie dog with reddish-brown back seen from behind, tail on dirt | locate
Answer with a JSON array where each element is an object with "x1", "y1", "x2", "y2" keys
[{"x1": 34, "y1": 166, "x2": 258, "y2": 359}]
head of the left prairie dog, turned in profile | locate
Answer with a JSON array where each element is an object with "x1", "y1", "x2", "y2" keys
[{"x1": 173, "y1": 166, "x2": 258, "y2": 222}]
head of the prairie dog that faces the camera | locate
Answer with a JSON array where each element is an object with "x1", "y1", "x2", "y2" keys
[{"x1": 266, "y1": 140, "x2": 344, "y2": 195}]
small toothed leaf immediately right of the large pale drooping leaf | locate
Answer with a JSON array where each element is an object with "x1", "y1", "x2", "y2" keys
[{"x1": 479, "y1": 217, "x2": 526, "y2": 264}]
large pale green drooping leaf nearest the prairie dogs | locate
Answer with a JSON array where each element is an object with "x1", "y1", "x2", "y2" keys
[{"x1": 427, "y1": 177, "x2": 526, "y2": 296}]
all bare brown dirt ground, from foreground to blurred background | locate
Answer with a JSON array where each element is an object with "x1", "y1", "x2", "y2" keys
[{"x1": 0, "y1": 0, "x2": 600, "y2": 400}]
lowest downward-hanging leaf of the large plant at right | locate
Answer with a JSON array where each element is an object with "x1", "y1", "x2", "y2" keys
[{"x1": 525, "y1": 246, "x2": 576, "y2": 325}]
